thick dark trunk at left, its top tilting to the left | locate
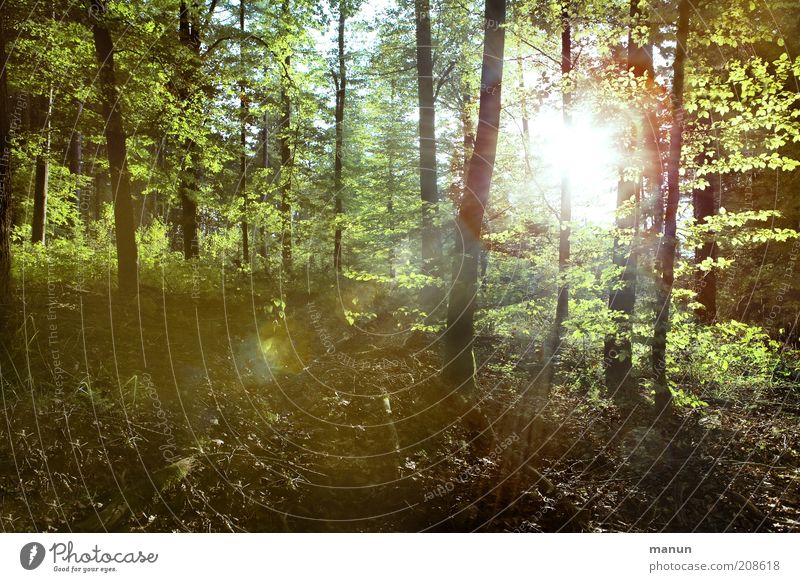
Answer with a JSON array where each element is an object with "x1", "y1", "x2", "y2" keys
[{"x1": 91, "y1": 0, "x2": 139, "y2": 295}]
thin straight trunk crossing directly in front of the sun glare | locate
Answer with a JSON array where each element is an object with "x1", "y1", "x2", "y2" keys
[{"x1": 548, "y1": 2, "x2": 572, "y2": 380}]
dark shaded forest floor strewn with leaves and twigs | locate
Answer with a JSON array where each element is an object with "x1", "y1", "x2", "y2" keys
[{"x1": 0, "y1": 287, "x2": 800, "y2": 532}]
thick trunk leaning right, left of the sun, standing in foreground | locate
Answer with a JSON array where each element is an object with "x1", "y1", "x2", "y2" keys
[{"x1": 444, "y1": 0, "x2": 506, "y2": 387}]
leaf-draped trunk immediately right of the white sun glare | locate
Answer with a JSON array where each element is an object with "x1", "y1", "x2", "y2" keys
[{"x1": 603, "y1": 0, "x2": 660, "y2": 403}]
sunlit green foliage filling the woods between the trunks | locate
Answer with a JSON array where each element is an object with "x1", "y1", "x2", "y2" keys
[{"x1": 3, "y1": 0, "x2": 800, "y2": 424}]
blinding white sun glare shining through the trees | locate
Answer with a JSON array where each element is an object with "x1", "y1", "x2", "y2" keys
[{"x1": 531, "y1": 109, "x2": 619, "y2": 223}]
